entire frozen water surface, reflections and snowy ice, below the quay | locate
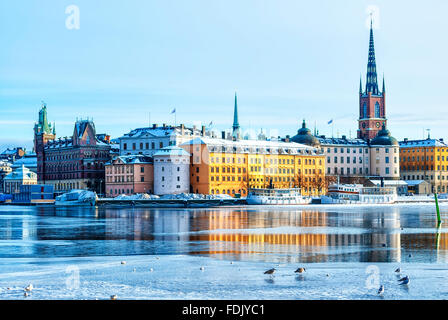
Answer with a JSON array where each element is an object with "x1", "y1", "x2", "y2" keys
[{"x1": 0, "y1": 204, "x2": 448, "y2": 299}]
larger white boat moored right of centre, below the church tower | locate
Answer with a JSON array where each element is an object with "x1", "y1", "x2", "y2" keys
[{"x1": 321, "y1": 184, "x2": 397, "y2": 204}]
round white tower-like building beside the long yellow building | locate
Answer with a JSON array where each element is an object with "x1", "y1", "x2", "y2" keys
[{"x1": 153, "y1": 146, "x2": 190, "y2": 195}]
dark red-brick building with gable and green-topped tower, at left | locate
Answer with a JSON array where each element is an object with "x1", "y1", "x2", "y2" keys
[{"x1": 34, "y1": 105, "x2": 111, "y2": 193}]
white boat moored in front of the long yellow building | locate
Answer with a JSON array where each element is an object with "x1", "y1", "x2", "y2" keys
[{"x1": 246, "y1": 188, "x2": 311, "y2": 205}]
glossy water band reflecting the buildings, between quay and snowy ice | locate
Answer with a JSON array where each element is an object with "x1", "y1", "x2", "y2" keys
[{"x1": 0, "y1": 206, "x2": 448, "y2": 263}]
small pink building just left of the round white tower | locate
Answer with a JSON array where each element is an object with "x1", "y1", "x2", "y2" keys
[{"x1": 105, "y1": 155, "x2": 154, "y2": 197}]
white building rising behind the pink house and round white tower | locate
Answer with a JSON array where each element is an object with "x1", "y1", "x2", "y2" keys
[{"x1": 118, "y1": 124, "x2": 210, "y2": 157}]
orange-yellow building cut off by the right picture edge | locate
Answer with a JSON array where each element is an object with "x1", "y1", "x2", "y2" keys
[{"x1": 400, "y1": 137, "x2": 448, "y2": 193}]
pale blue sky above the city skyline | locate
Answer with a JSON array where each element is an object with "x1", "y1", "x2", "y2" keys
[{"x1": 0, "y1": 0, "x2": 448, "y2": 149}]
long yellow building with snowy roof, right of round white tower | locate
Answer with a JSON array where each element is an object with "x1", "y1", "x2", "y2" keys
[{"x1": 181, "y1": 137, "x2": 325, "y2": 197}]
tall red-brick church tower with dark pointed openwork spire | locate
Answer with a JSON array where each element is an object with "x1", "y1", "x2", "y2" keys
[{"x1": 358, "y1": 20, "x2": 387, "y2": 140}]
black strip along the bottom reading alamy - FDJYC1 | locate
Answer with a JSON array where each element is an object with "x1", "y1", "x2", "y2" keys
[{"x1": 0, "y1": 300, "x2": 440, "y2": 319}]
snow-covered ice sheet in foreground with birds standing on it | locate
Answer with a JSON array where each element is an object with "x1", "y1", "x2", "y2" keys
[{"x1": 0, "y1": 255, "x2": 448, "y2": 300}]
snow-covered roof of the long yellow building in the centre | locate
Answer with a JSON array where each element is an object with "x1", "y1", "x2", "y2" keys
[{"x1": 182, "y1": 137, "x2": 320, "y2": 154}]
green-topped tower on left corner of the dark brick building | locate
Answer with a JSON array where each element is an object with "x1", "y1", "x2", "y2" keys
[{"x1": 34, "y1": 102, "x2": 56, "y2": 183}]
